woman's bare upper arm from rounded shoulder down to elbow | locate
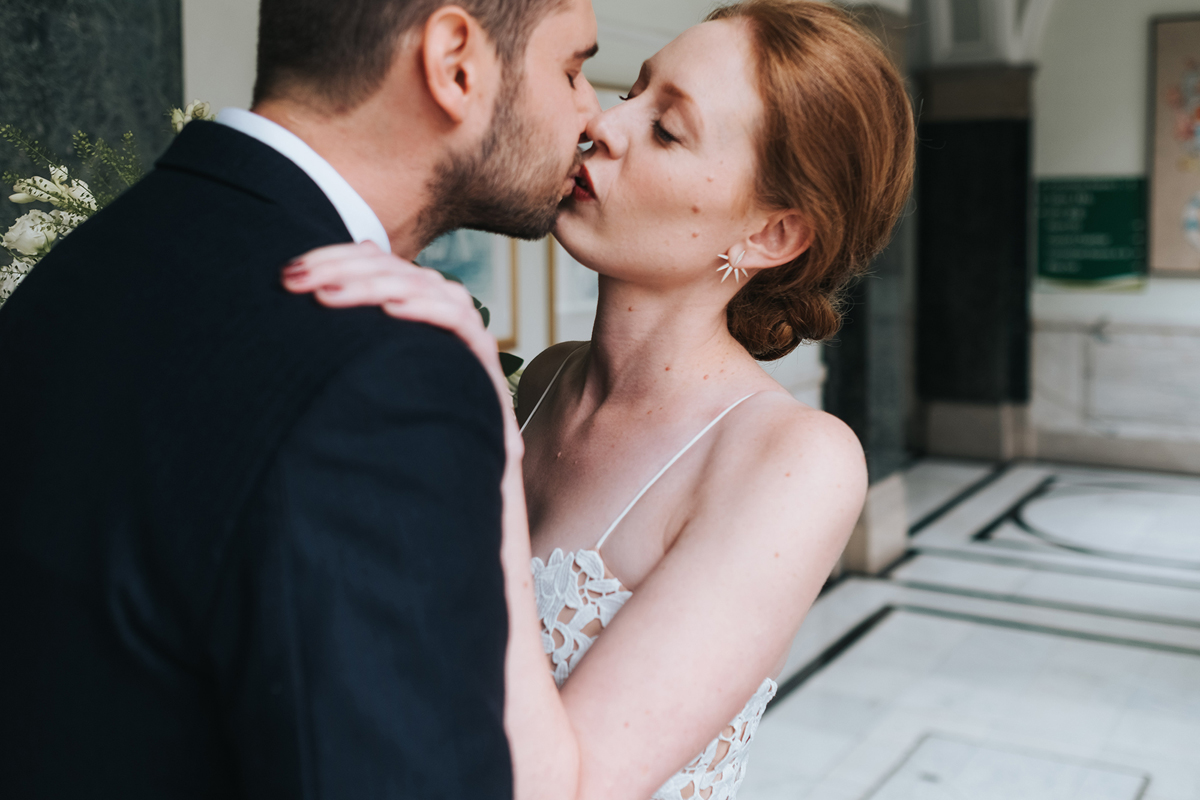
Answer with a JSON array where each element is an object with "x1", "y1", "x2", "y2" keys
[{"x1": 552, "y1": 396, "x2": 866, "y2": 800}]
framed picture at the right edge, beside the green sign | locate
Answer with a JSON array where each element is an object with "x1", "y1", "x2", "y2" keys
[{"x1": 1148, "y1": 14, "x2": 1200, "y2": 277}]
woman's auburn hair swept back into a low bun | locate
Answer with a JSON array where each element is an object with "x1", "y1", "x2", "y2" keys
[{"x1": 708, "y1": 0, "x2": 916, "y2": 361}]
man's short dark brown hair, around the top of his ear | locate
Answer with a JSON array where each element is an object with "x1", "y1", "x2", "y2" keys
[{"x1": 254, "y1": 0, "x2": 566, "y2": 109}]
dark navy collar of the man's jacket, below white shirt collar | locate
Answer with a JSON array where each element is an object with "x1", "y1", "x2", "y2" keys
[{"x1": 155, "y1": 120, "x2": 350, "y2": 241}]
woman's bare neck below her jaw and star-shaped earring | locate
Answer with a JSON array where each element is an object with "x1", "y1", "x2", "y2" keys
[{"x1": 583, "y1": 276, "x2": 749, "y2": 408}]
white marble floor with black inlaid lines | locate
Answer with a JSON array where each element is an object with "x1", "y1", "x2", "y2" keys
[{"x1": 739, "y1": 461, "x2": 1200, "y2": 800}]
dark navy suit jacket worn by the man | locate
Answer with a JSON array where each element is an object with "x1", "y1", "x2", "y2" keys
[{"x1": 0, "y1": 122, "x2": 512, "y2": 800}]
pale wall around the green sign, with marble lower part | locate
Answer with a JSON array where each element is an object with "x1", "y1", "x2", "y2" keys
[{"x1": 1032, "y1": 0, "x2": 1200, "y2": 471}]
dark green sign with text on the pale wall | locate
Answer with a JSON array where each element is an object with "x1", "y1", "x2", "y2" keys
[{"x1": 1038, "y1": 178, "x2": 1146, "y2": 284}]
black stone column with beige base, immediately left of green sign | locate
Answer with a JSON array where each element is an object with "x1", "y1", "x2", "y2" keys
[{"x1": 917, "y1": 67, "x2": 1033, "y2": 459}]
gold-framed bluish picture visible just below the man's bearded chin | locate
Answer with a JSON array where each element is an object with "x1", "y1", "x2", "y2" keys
[{"x1": 416, "y1": 230, "x2": 517, "y2": 350}]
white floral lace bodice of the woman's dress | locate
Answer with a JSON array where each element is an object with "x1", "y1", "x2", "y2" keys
[{"x1": 533, "y1": 549, "x2": 779, "y2": 800}]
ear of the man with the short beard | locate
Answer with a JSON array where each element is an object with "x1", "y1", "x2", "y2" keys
[{"x1": 421, "y1": 6, "x2": 499, "y2": 125}]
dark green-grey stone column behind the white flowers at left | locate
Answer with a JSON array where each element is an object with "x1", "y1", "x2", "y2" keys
[{"x1": 0, "y1": 0, "x2": 184, "y2": 228}]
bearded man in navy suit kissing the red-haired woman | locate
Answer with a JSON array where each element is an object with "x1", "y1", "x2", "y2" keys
[{"x1": 0, "y1": 0, "x2": 598, "y2": 800}]
